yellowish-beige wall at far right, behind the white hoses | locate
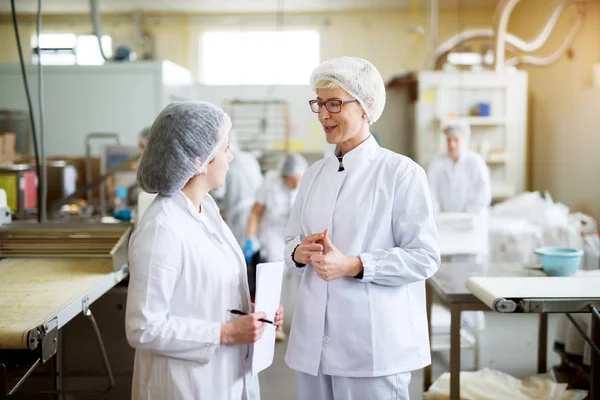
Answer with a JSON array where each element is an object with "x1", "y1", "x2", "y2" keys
[{"x1": 509, "y1": 0, "x2": 600, "y2": 220}]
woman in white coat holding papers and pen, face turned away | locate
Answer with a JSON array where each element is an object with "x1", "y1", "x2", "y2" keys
[{"x1": 126, "y1": 102, "x2": 283, "y2": 400}]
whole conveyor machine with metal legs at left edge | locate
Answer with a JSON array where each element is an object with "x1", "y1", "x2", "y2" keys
[{"x1": 0, "y1": 223, "x2": 131, "y2": 398}]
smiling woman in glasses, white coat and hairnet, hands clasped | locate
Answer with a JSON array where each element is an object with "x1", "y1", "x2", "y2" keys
[{"x1": 284, "y1": 57, "x2": 440, "y2": 400}]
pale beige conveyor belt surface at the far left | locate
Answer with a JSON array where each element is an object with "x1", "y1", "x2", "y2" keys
[{"x1": 0, "y1": 258, "x2": 118, "y2": 349}]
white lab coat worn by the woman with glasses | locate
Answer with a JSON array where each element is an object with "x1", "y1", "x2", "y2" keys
[{"x1": 284, "y1": 136, "x2": 440, "y2": 377}]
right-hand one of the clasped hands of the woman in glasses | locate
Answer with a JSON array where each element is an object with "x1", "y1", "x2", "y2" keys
[{"x1": 310, "y1": 229, "x2": 363, "y2": 281}]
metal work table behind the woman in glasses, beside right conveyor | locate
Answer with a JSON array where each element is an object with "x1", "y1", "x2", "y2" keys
[{"x1": 423, "y1": 263, "x2": 548, "y2": 400}]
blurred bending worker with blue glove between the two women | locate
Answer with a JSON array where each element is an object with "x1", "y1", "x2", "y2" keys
[{"x1": 244, "y1": 153, "x2": 308, "y2": 341}]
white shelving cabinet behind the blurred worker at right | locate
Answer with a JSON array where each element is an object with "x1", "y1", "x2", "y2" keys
[{"x1": 387, "y1": 71, "x2": 527, "y2": 200}]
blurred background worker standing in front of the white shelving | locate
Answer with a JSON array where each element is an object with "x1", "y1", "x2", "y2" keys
[{"x1": 427, "y1": 121, "x2": 492, "y2": 262}]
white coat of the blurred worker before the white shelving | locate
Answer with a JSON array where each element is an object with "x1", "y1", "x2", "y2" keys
[{"x1": 427, "y1": 149, "x2": 492, "y2": 261}]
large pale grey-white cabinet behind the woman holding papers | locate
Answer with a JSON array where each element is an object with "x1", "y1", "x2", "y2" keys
[{"x1": 0, "y1": 61, "x2": 193, "y2": 156}]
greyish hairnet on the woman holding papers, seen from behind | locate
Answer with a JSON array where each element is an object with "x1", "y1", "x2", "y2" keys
[{"x1": 137, "y1": 101, "x2": 231, "y2": 195}]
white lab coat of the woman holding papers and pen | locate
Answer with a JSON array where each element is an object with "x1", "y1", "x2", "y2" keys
[{"x1": 126, "y1": 192, "x2": 259, "y2": 400}]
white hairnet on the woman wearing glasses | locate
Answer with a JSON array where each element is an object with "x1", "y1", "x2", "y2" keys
[{"x1": 310, "y1": 57, "x2": 385, "y2": 124}]
